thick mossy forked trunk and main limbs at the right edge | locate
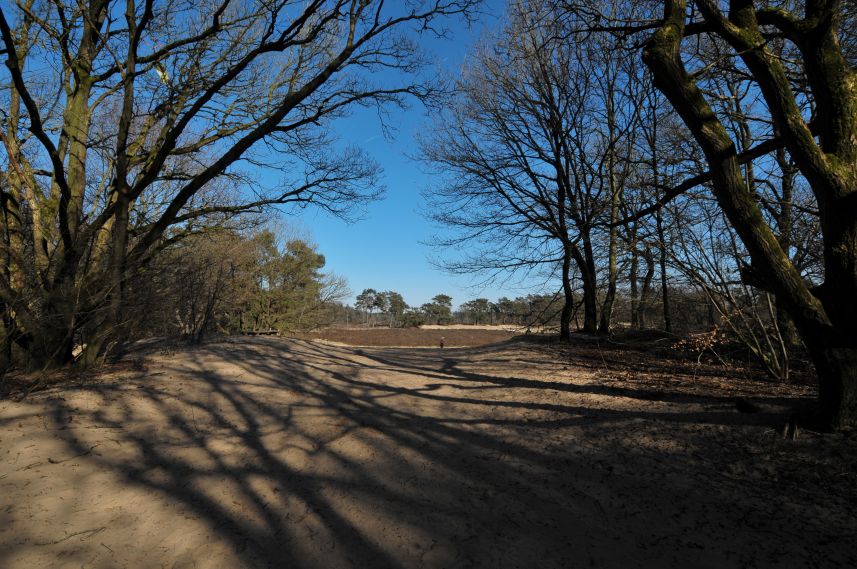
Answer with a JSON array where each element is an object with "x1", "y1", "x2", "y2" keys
[{"x1": 643, "y1": 0, "x2": 857, "y2": 429}]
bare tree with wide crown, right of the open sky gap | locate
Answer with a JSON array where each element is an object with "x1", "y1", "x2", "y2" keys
[{"x1": 423, "y1": 2, "x2": 628, "y2": 338}]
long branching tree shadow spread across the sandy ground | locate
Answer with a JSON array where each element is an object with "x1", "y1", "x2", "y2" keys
[{"x1": 5, "y1": 339, "x2": 841, "y2": 568}]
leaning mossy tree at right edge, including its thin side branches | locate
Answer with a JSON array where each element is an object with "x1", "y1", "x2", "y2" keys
[{"x1": 567, "y1": 0, "x2": 857, "y2": 428}]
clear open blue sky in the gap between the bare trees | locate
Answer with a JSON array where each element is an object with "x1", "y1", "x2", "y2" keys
[{"x1": 284, "y1": 0, "x2": 556, "y2": 306}]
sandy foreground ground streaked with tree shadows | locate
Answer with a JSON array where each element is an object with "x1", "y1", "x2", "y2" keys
[{"x1": 0, "y1": 338, "x2": 857, "y2": 569}]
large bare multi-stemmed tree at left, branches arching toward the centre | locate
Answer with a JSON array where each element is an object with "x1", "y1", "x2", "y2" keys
[{"x1": 0, "y1": 0, "x2": 474, "y2": 365}]
